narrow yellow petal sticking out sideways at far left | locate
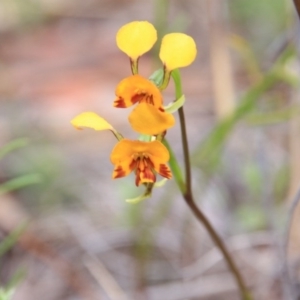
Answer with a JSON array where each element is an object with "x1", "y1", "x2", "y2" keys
[{"x1": 71, "y1": 112, "x2": 114, "y2": 131}]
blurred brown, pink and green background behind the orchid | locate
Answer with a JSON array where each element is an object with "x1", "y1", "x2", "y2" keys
[{"x1": 0, "y1": 0, "x2": 300, "y2": 300}]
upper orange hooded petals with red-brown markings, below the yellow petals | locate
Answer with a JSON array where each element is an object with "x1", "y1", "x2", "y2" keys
[{"x1": 114, "y1": 74, "x2": 163, "y2": 108}]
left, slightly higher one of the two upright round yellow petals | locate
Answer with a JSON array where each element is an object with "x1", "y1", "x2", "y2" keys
[{"x1": 116, "y1": 21, "x2": 157, "y2": 60}]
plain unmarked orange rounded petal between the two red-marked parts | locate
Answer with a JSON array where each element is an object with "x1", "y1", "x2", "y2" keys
[{"x1": 129, "y1": 102, "x2": 175, "y2": 135}]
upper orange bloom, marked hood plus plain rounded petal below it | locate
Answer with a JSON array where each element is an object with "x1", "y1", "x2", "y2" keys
[{"x1": 114, "y1": 74, "x2": 175, "y2": 135}]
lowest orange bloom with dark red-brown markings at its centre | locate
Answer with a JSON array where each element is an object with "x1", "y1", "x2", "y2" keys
[{"x1": 110, "y1": 139, "x2": 172, "y2": 186}]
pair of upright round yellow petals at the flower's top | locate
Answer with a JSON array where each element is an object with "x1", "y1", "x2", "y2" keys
[{"x1": 116, "y1": 21, "x2": 197, "y2": 71}]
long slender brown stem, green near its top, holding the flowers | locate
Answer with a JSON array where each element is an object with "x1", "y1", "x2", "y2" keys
[{"x1": 172, "y1": 70, "x2": 252, "y2": 300}]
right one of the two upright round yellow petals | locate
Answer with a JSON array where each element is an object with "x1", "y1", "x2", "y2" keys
[{"x1": 159, "y1": 33, "x2": 197, "y2": 71}]
